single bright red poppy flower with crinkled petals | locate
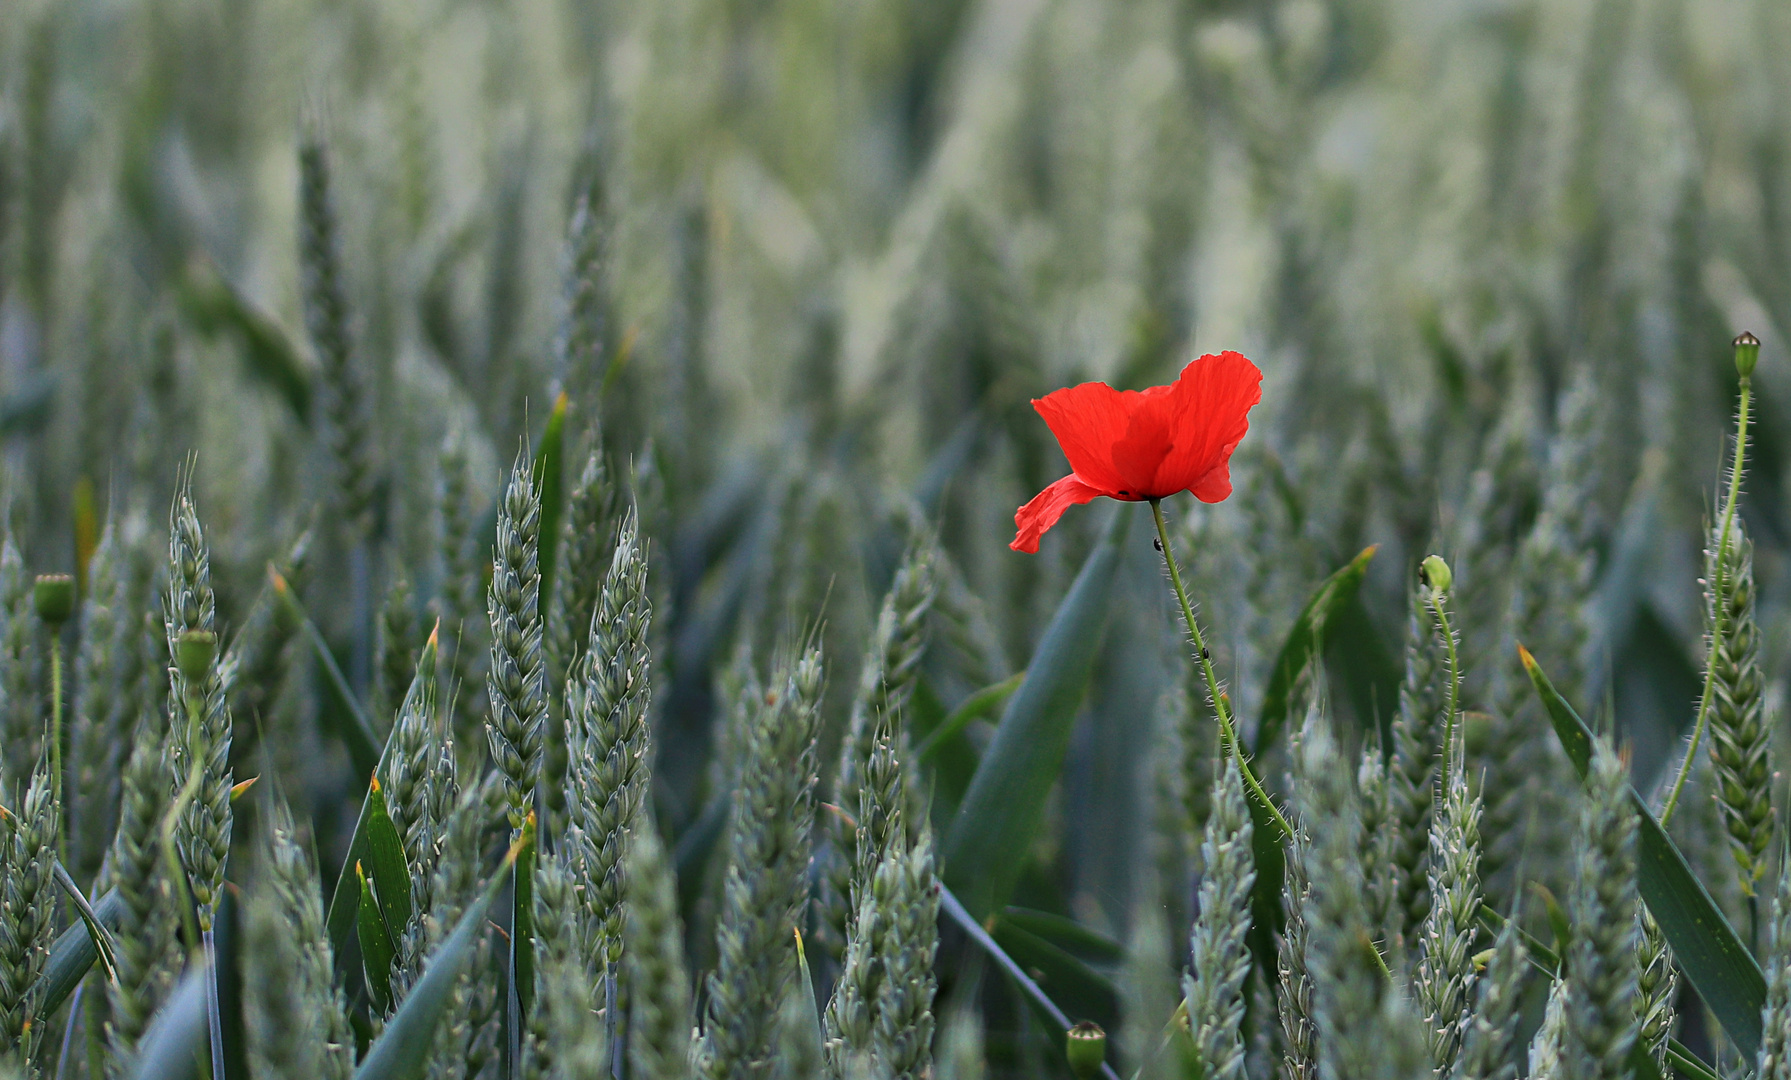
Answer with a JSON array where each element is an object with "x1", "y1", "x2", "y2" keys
[{"x1": 1008, "y1": 353, "x2": 1263, "y2": 552}]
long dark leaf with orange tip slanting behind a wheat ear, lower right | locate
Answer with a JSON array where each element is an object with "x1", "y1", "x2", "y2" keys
[{"x1": 1517, "y1": 645, "x2": 1766, "y2": 1060}]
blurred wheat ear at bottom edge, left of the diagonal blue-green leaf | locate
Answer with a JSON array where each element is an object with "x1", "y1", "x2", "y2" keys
[{"x1": 244, "y1": 801, "x2": 355, "y2": 1080}]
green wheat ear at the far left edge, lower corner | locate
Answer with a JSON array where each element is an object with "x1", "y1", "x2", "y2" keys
[{"x1": 0, "y1": 761, "x2": 59, "y2": 1073}]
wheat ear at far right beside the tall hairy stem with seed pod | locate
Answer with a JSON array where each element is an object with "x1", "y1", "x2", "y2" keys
[{"x1": 1705, "y1": 518, "x2": 1773, "y2": 897}]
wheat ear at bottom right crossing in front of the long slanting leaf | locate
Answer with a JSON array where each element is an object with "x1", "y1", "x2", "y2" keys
[{"x1": 1567, "y1": 741, "x2": 1639, "y2": 1076}]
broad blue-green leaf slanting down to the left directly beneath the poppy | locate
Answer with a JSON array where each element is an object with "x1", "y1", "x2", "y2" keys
[{"x1": 944, "y1": 505, "x2": 1132, "y2": 919}]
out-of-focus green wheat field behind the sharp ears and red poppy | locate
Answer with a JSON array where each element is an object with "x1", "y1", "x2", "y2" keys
[{"x1": 0, "y1": 0, "x2": 1791, "y2": 1024}]
